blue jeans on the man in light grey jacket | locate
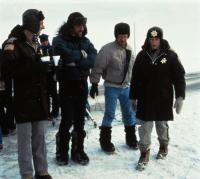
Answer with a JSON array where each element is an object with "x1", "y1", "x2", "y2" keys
[{"x1": 102, "y1": 87, "x2": 136, "y2": 127}]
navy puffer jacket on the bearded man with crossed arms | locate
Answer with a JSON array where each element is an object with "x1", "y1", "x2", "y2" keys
[{"x1": 52, "y1": 34, "x2": 97, "y2": 82}]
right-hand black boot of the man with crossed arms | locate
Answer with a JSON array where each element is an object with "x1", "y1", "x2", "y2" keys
[{"x1": 71, "y1": 130, "x2": 89, "y2": 165}]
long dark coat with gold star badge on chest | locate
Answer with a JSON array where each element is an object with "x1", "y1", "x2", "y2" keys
[{"x1": 130, "y1": 40, "x2": 185, "y2": 121}]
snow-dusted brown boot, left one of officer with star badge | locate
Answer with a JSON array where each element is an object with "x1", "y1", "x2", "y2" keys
[{"x1": 136, "y1": 149, "x2": 150, "y2": 171}]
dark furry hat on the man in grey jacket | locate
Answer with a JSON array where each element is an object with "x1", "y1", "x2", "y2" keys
[{"x1": 114, "y1": 22, "x2": 130, "y2": 38}]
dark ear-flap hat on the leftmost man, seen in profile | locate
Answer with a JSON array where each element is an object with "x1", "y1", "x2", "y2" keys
[{"x1": 22, "y1": 9, "x2": 44, "y2": 34}]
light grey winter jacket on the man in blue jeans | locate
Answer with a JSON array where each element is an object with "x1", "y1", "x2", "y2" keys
[{"x1": 90, "y1": 41, "x2": 134, "y2": 87}]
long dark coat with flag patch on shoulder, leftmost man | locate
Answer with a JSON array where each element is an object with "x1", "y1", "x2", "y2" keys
[{"x1": 2, "y1": 25, "x2": 47, "y2": 123}]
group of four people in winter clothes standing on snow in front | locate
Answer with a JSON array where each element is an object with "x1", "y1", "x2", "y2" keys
[{"x1": 1, "y1": 9, "x2": 185, "y2": 179}]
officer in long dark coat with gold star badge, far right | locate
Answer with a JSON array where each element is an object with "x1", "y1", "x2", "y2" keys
[{"x1": 130, "y1": 27, "x2": 185, "y2": 171}]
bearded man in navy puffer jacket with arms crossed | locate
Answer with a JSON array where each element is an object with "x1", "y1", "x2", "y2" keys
[{"x1": 52, "y1": 12, "x2": 97, "y2": 165}]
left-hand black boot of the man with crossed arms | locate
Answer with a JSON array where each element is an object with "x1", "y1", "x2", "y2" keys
[{"x1": 56, "y1": 132, "x2": 71, "y2": 165}]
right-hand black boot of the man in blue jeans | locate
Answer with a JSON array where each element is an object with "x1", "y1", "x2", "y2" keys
[{"x1": 125, "y1": 125, "x2": 138, "y2": 150}]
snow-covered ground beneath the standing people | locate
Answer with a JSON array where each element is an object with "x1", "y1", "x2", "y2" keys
[{"x1": 0, "y1": 74, "x2": 200, "y2": 179}]
